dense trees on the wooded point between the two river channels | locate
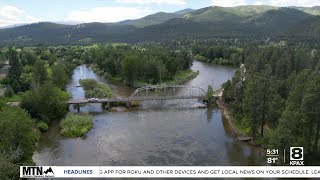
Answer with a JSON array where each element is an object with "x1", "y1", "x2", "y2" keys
[{"x1": 89, "y1": 46, "x2": 192, "y2": 86}]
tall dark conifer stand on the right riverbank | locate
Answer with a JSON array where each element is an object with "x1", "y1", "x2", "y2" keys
[{"x1": 223, "y1": 47, "x2": 320, "y2": 164}]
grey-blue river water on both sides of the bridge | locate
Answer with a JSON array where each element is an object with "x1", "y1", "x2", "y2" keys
[{"x1": 33, "y1": 62, "x2": 266, "y2": 166}]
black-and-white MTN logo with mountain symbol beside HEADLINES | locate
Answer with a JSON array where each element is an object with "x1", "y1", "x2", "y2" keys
[{"x1": 20, "y1": 166, "x2": 55, "y2": 178}]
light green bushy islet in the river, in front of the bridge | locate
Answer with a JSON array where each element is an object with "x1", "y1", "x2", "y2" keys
[{"x1": 60, "y1": 113, "x2": 93, "y2": 138}]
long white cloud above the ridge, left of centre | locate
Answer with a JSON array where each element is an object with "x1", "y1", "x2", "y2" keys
[{"x1": 67, "y1": 7, "x2": 152, "y2": 22}]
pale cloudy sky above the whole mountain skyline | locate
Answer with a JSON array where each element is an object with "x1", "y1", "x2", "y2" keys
[{"x1": 0, "y1": 0, "x2": 320, "y2": 27}]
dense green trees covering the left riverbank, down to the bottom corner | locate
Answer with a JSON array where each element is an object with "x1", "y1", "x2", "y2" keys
[{"x1": 0, "y1": 47, "x2": 76, "y2": 179}]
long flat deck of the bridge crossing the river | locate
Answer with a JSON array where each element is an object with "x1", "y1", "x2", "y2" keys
[{"x1": 68, "y1": 96, "x2": 204, "y2": 104}]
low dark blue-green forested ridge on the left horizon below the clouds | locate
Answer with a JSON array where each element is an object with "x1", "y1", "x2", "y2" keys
[{"x1": 0, "y1": 22, "x2": 136, "y2": 44}]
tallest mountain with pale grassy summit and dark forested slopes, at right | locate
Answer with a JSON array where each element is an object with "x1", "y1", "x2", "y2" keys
[{"x1": 129, "y1": 6, "x2": 314, "y2": 42}]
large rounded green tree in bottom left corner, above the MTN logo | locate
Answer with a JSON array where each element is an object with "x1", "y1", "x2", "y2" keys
[{"x1": 0, "y1": 107, "x2": 39, "y2": 179}]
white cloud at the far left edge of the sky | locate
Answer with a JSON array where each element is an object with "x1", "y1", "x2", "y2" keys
[{"x1": 0, "y1": 5, "x2": 39, "y2": 27}]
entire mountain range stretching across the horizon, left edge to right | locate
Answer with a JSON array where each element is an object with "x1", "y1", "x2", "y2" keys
[{"x1": 0, "y1": 6, "x2": 320, "y2": 45}]
